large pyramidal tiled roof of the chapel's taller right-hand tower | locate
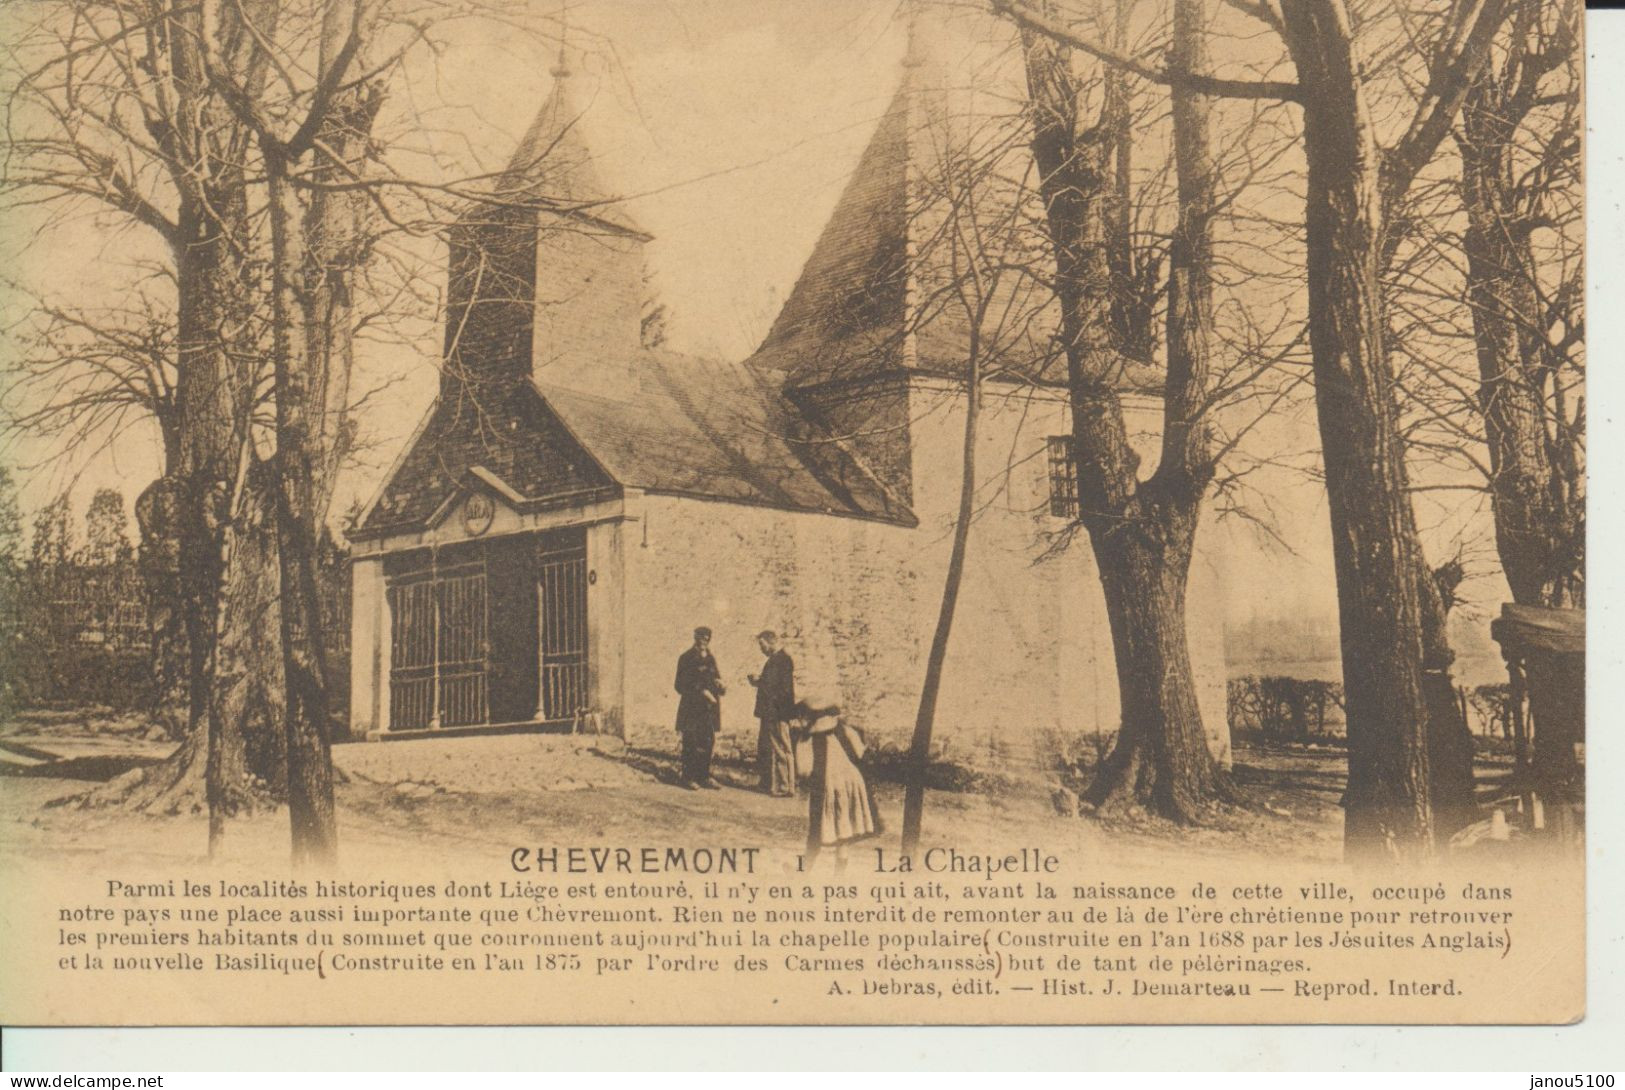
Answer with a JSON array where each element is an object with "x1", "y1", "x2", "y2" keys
[{"x1": 751, "y1": 68, "x2": 1160, "y2": 390}]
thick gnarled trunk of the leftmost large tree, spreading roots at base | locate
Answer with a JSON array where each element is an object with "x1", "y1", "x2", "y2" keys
[{"x1": 48, "y1": 0, "x2": 289, "y2": 854}]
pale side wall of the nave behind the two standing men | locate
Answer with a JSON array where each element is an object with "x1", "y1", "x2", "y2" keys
[{"x1": 624, "y1": 495, "x2": 930, "y2": 750}]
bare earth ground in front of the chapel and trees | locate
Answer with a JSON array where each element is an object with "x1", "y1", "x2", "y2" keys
[{"x1": 0, "y1": 710, "x2": 1521, "y2": 864}]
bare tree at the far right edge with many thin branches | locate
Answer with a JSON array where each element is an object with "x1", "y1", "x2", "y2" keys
[{"x1": 1456, "y1": 3, "x2": 1586, "y2": 789}]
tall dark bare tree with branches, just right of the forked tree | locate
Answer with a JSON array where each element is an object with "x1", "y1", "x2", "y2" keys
[{"x1": 993, "y1": 0, "x2": 1510, "y2": 856}]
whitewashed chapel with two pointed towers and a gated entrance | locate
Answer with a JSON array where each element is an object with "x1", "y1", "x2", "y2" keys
[{"x1": 351, "y1": 40, "x2": 1229, "y2": 760}]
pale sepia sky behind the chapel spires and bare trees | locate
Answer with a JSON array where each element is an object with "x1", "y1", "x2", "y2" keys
[{"x1": 0, "y1": 0, "x2": 1497, "y2": 672}]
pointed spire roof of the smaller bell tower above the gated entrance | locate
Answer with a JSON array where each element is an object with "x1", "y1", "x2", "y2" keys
[{"x1": 496, "y1": 60, "x2": 647, "y2": 237}]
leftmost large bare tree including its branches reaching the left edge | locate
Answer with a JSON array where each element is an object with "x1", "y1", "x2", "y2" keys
[{"x1": 5, "y1": 0, "x2": 286, "y2": 846}]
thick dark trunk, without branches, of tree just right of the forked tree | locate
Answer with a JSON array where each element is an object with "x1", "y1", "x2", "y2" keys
[{"x1": 1282, "y1": 0, "x2": 1433, "y2": 858}]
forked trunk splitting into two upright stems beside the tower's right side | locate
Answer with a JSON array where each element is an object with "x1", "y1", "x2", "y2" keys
[{"x1": 1022, "y1": 0, "x2": 1237, "y2": 822}]
